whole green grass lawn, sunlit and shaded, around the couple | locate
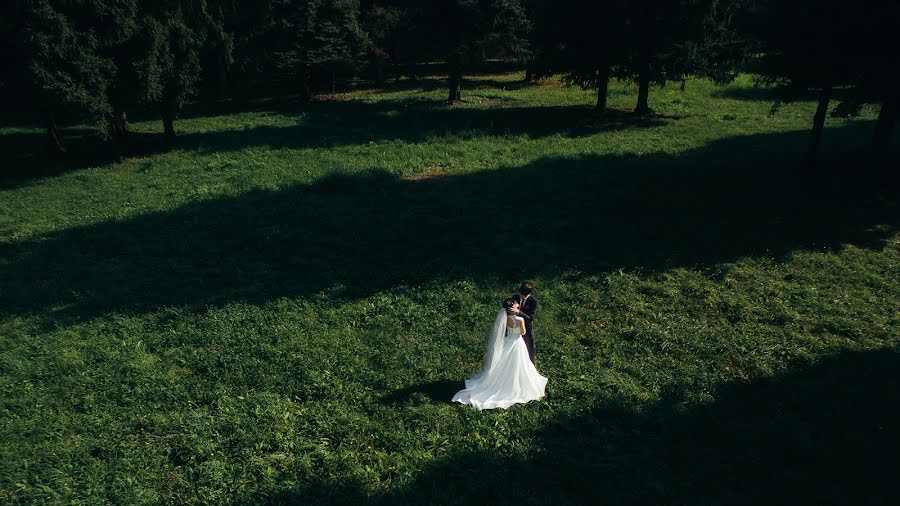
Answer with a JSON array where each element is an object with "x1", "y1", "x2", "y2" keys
[{"x1": 0, "y1": 74, "x2": 900, "y2": 504}]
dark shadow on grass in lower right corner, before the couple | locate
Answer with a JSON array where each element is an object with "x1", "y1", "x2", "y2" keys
[{"x1": 258, "y1": 349, "x2": 900, "y2": 505}]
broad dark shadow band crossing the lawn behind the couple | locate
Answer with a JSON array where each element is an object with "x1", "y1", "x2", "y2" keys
[{"x1": 0, "y1": 125, "x2": 900, "y2": 325}]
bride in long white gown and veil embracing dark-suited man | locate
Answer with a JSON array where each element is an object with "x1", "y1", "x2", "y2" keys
[{"x1": 453, "y1": 299, "x2": 547, "y2": 410}]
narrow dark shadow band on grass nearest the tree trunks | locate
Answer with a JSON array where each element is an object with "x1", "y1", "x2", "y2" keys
[{"x1": 0, "y1": 98, "x2": 660, "y2": 189}]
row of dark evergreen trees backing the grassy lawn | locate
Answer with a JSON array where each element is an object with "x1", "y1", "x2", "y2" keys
[{"x1": 0, "y1": 0, "x2": 900, "y2": 159}]
